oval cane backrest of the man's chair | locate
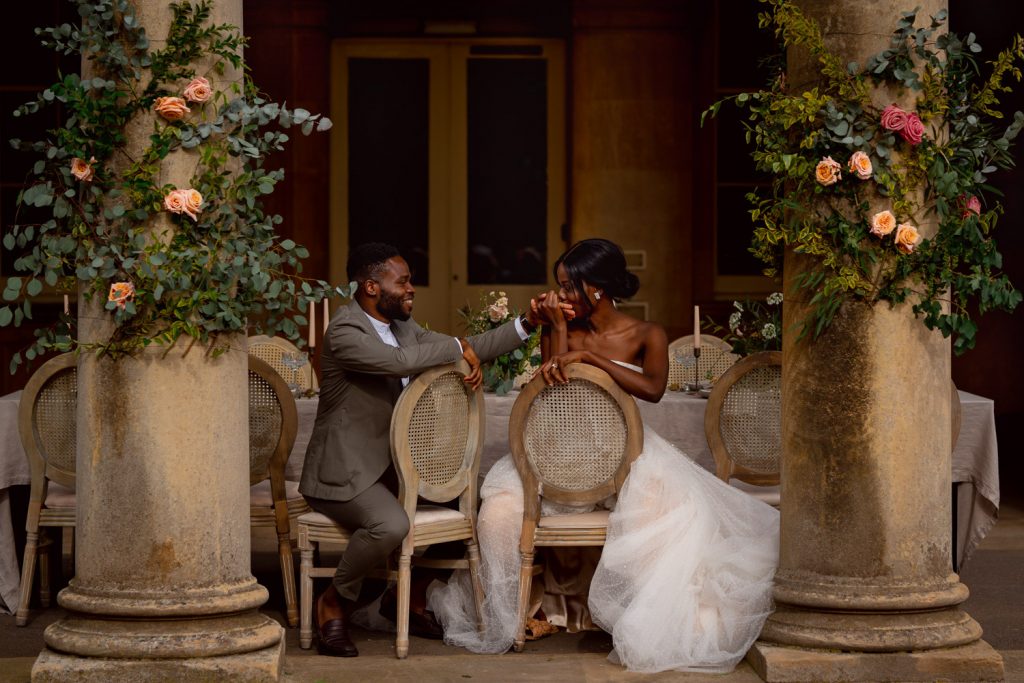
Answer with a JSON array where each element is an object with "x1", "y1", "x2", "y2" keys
[{"x1": 391, "y1": 360, "x2": 486, "y2": 519}]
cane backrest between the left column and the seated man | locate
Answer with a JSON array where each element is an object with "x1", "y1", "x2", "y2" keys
[{"x1": 249, "y1": 355, "x2": 299, "y2": 489}]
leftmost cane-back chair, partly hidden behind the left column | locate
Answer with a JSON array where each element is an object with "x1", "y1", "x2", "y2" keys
[{"x1": 14, "y1": 353, "x2": 78, "y2": 626}]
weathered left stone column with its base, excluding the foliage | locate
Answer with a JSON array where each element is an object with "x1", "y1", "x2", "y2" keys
[{"x1": 32, "y1": 0, "x2": 285, "y2": 682}]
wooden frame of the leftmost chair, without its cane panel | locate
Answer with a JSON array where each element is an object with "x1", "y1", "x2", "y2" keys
[{"x1": 14, "y1": 353, "x2": 78, "y2": 626}]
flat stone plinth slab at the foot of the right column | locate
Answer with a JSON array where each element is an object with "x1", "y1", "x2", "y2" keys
[{"x1": 749, "y1": 640, "x2": 1004, "y2": 683}]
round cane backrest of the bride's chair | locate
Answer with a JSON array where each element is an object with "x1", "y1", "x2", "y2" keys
[{"x1": 509, "y1": 362, "x2": 643, "y2": 519}]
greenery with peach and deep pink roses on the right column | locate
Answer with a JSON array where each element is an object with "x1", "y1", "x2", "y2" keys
[{"x1": 701, "y1": 0, "x2": 1024, "y2": 353}]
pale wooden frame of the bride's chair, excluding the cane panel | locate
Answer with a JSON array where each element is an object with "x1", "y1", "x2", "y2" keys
[{"x1": 509, "y1": 364, "x2": 643, "y2": 652}]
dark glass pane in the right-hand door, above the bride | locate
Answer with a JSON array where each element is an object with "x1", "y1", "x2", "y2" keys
[{"x1": 466, "y1": 58, "x2": 548, "y2": 285}]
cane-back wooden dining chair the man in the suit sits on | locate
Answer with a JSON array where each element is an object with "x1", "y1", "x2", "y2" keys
[{"x1": 299, "y1": 360, "x2": 485, "y2": 658}]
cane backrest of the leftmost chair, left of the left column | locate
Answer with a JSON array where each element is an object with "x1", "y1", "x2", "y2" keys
[{"x1": 17, "y1": 353, "x2": 78, "y2": 491}]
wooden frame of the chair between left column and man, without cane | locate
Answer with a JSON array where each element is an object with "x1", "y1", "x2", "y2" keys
[{"x1": 249, "y1": 355, "x2": 309, "y2": 627}]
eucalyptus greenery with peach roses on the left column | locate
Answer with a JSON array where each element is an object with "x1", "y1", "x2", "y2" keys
[{"x1": 0, "y1": 0, "x2": 350, "y2": 371}]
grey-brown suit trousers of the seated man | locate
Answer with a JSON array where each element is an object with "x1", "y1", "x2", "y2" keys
[{"x1": 306, "y1": 470, "x2": 409, "y2": 602}]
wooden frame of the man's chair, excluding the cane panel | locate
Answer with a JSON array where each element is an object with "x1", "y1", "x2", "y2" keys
[{"x1": 299, "y1": 360, "x2": 485, "y2": 658}]
